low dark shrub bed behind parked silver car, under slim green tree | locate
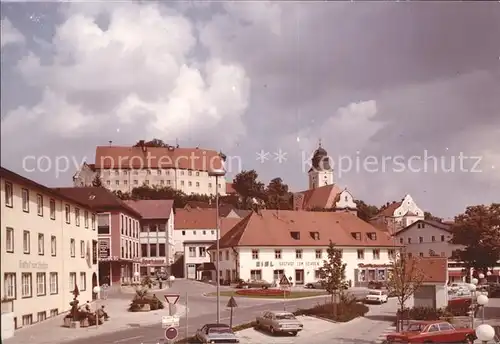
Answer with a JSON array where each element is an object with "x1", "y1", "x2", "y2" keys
[{"x1": 294, "y1": 295, "x2": 369, "y2": 322}]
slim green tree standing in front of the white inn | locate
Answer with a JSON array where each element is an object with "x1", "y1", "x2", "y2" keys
[{"x1": 319, "y1": 240, "x2": 348, "y2": 317}]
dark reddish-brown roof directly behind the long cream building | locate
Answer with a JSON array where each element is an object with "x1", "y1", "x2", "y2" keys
[{"x1": 53, "y1": 187, "x2": 141, "y2": 218}]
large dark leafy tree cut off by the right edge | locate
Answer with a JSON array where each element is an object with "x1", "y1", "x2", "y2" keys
[{"x1": 451, "y1": 203, "x2": 500, "y2": 272}]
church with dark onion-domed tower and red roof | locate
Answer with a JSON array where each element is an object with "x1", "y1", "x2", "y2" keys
[{"x1": 293, "y1": 142, "x2": 357, "y2": 214}]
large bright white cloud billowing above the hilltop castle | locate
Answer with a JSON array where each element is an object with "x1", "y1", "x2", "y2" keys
[{"x1": 2, "y1": 4, "x2": 249, "y2": 146}]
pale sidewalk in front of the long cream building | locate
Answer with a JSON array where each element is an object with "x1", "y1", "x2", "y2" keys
[{"x1": 3, "y1": 296, "x2": 186, "y2": 344}]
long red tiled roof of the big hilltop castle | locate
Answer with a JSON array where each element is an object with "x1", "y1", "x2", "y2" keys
[{"x1": 95, "y1": 146, "x2": 223, "y2": 171}]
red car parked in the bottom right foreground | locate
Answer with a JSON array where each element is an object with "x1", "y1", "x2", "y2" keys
[{"x1": 386, "y1": 320, "x2": 476, "y2": 344}]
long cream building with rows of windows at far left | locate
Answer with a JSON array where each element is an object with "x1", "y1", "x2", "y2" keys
[{"x1": 0, "y1": 168, "x2": 98, "y2": 328}]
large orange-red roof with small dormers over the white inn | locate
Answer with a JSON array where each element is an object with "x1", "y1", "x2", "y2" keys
[{"x1": 214, "y1": 210, "x2": 400, "y2": 248}]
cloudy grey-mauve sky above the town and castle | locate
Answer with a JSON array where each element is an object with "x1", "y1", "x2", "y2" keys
[{"x1": 1, "y1": 1, "x2": 500, "y2": 218}]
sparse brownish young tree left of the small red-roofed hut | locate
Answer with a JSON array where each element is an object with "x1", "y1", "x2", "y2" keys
[{"x1": 387, "y1": 253, "x2": 425, "y2": 328}]
